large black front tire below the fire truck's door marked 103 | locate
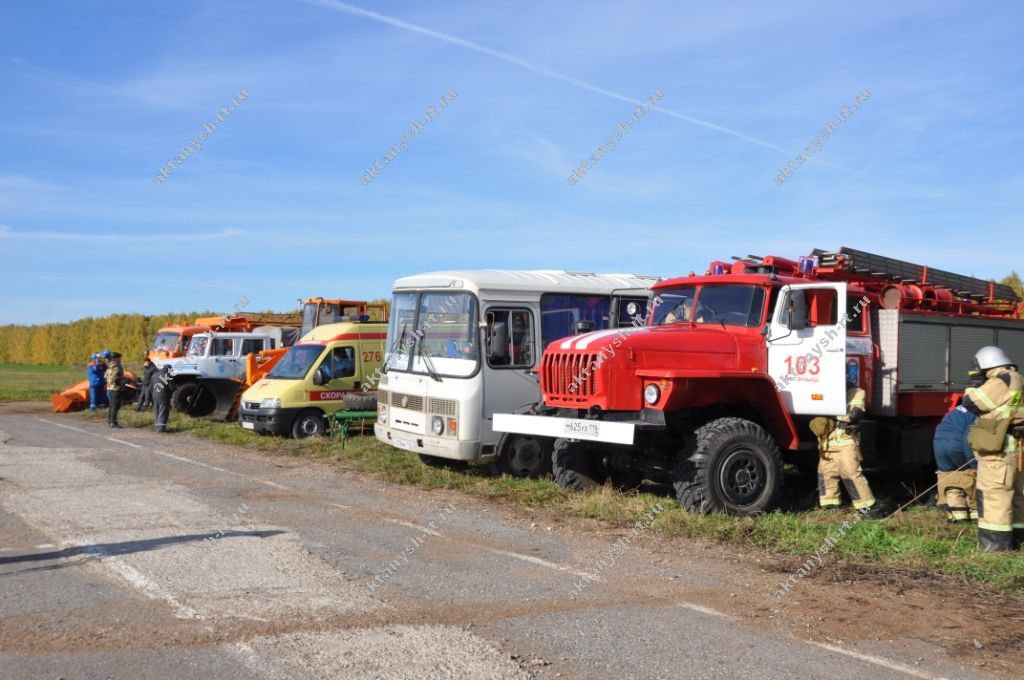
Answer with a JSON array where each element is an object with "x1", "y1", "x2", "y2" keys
[{"x1": 672, "y1": 418, "x2": 782, "y2": 515}]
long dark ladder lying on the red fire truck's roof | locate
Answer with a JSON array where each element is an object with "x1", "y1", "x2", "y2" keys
[{"x1": 811, "y1": 246, "x2": 1020, "y2": 302}]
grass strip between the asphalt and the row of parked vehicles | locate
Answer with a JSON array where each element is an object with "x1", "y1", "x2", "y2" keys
[{"x1": 95, "y1": 405, "x2": 1024, "y2": 597}]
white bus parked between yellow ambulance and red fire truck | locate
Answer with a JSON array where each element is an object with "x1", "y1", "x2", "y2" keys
[{"x1": 368, "y1": 269, "x2": 658, "y2": 477}]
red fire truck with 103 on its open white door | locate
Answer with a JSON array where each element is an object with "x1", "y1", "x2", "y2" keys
[{"x1": 494, "y1": 248, "x2": 1024, "y2": 514}]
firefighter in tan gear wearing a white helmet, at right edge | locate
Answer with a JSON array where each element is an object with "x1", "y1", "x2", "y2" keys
[{"x1": 964, "y1": 346, "x2": 1024, "y2": 551}]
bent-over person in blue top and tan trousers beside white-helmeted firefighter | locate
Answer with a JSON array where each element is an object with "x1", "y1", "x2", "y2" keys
[{"x1": 932, "y1": 405, "x2": 978, "y2": 522}]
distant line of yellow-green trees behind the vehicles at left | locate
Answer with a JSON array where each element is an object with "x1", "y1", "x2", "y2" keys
[{"x1": 0, "y1": 311, "x2": 210, "y2": 366}]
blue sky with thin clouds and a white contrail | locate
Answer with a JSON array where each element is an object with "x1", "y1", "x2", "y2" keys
[{"x1": 0, "y1": 0, "x2": 1024, "y2": 324}]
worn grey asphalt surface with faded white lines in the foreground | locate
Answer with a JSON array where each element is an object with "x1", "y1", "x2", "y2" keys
[{"x1": 0, "y1": 412, "x2": 1020, "y2": 680}]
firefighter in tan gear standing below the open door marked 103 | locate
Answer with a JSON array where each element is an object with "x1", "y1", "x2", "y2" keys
[{"x1": 811, "y1": 382, "x2": 881, "y2": 519}]
